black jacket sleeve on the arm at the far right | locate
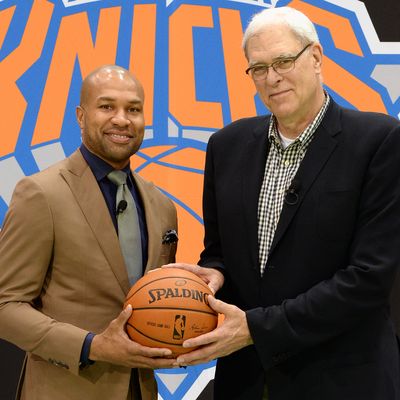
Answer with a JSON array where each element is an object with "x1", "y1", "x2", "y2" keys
[{"x1": 246, "y1": 127, "x2": 400, "y2": 369}]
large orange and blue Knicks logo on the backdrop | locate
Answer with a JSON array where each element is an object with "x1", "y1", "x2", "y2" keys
[{"x1": 0, "y1": 0, "x2": 400, "y2": 262}]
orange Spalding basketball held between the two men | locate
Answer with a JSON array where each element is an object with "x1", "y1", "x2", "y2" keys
[{"x1": 124, "y1": 268, "x2": 218, "y2": 356}]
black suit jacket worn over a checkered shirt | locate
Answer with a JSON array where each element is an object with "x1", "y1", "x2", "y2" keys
[{"x1": 200, "y1": 101, "x2": 400, "y2": 400}]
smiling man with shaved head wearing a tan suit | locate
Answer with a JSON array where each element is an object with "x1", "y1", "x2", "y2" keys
[{"x1": 0, "y1": 66, "x2": 177, "y2": 400}]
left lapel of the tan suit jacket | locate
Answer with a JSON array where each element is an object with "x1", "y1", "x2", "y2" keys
[{"x1": 60, "y1": 150, "x2": 130, "y2": 293}]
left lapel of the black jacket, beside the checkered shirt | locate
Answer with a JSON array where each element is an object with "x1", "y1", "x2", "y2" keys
[{"x1": 242, "y1": 117, "x2": 269, "y2": 267}]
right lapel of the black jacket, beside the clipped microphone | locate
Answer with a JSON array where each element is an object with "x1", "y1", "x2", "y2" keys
[{"x1": 270, "y1": 99, "x2": 340, "y2": 254}]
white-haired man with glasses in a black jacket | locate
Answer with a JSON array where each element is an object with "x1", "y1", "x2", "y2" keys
[{"x1": 165, "y1": 7, "x2": 400, "y2": 400}]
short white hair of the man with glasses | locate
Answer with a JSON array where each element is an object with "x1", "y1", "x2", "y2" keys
[{"x1": 242, "y1": 7, "x2": 319, "y2": 55}]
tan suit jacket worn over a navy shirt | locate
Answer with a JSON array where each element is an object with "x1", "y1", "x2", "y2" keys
[{"x1": 0, "y1": 150, "x2": 177, "y2": 400}]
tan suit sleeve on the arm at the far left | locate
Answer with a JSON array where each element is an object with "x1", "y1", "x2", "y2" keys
[{"x1": 0, "y1": 178, "x2": 88, "y2": 374}]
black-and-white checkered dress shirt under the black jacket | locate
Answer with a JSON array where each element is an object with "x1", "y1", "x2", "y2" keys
[{"x1": 258, "y1": 94, "x2": 329, "y2": 275}]
